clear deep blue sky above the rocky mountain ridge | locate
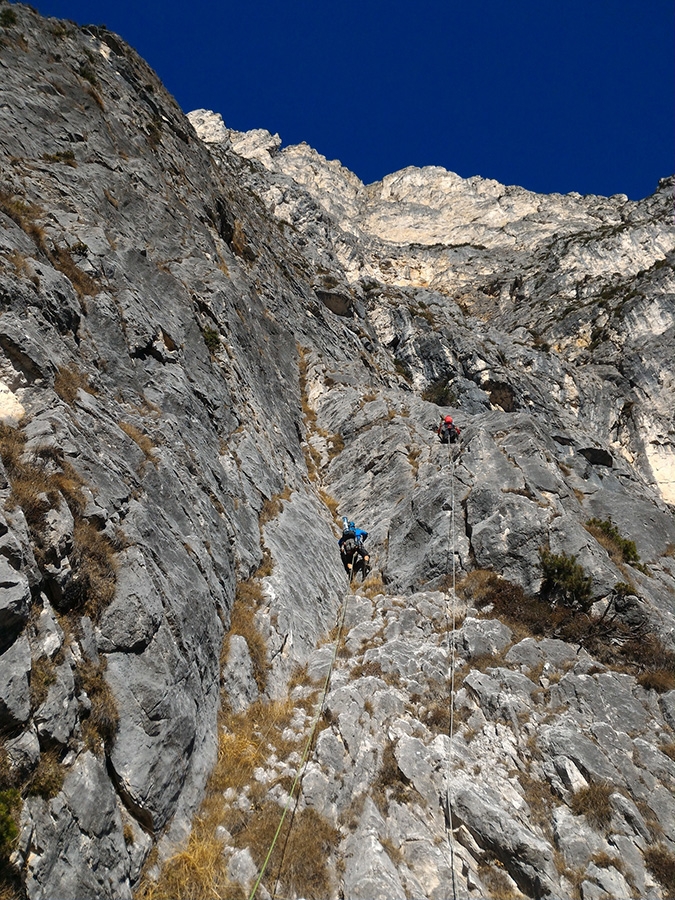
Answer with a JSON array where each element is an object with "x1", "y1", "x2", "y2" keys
[{"x1": 34, "y1": 0, "x2": 675, "y2": 199}]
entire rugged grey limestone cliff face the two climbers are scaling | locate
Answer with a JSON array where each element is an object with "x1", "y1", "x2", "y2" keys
[{"x1": 0, "y1": 4, "x2": 675, "y2": 898}]
